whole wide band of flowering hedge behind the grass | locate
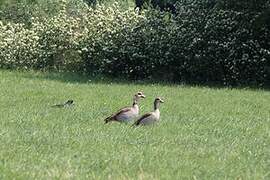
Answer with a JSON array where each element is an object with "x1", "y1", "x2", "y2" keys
[{"x1": 0, "y1": 0, "x2": 270, "y2": 85}]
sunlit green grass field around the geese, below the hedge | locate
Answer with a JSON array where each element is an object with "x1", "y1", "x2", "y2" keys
[{"x1": 0, "y1": 70, "x2": 270, "y2": 179}]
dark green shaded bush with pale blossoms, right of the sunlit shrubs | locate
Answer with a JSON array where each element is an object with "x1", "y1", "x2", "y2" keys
[{"x1": 82, "y1": 1, "x2": 269, "y2": 85}]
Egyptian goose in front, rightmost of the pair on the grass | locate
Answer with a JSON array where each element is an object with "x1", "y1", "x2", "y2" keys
[{"x1": 133, "y1": 97, "x2": 164, "y2": 126}]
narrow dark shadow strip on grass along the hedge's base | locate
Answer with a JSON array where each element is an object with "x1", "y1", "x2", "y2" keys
[{"x1": 5, "y1": 71, "x2": 270, "y2": 91}]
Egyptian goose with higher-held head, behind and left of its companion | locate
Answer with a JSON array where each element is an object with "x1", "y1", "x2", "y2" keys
[{"x1": 104, "y1": 92, "x2": 145, "y2": 124}]
